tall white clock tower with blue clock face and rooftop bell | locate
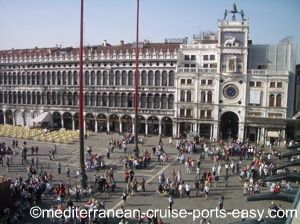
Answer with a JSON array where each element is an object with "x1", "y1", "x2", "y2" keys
[{"x1": 217, "y1": 3, "x2": 249, "y2": 140}]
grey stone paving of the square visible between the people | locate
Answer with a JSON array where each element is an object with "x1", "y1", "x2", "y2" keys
[{"x1": 0, "y1": 133, "x2": 291, "y2": 224}]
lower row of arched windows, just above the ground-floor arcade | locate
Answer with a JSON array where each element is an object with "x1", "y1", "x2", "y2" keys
[{"x1": 0, "y1": 91, "x2": 174, "y2": 109}]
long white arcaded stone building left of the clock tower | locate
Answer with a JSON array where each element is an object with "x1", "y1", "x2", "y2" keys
[{"x1": 0, "y1": 42, "x2": 179, "y2": 135}]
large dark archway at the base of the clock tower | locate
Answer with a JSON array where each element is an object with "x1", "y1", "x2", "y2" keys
[{"x1": 220, "y1": 112, "x2": 239, "y2": 140}]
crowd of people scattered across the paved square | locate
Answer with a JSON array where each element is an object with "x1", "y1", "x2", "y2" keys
[{"x1": 0, "y1": 133, "x2": 293, "y2": 224}]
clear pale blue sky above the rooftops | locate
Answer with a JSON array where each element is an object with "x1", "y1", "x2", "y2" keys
[{"x1": 0, "y1": 0, "x2": 300, "y2": 63}]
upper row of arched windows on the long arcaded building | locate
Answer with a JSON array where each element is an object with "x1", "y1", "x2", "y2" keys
[{"x1": 0, "y1": 70, "x2": 175, "y2": 86}]
